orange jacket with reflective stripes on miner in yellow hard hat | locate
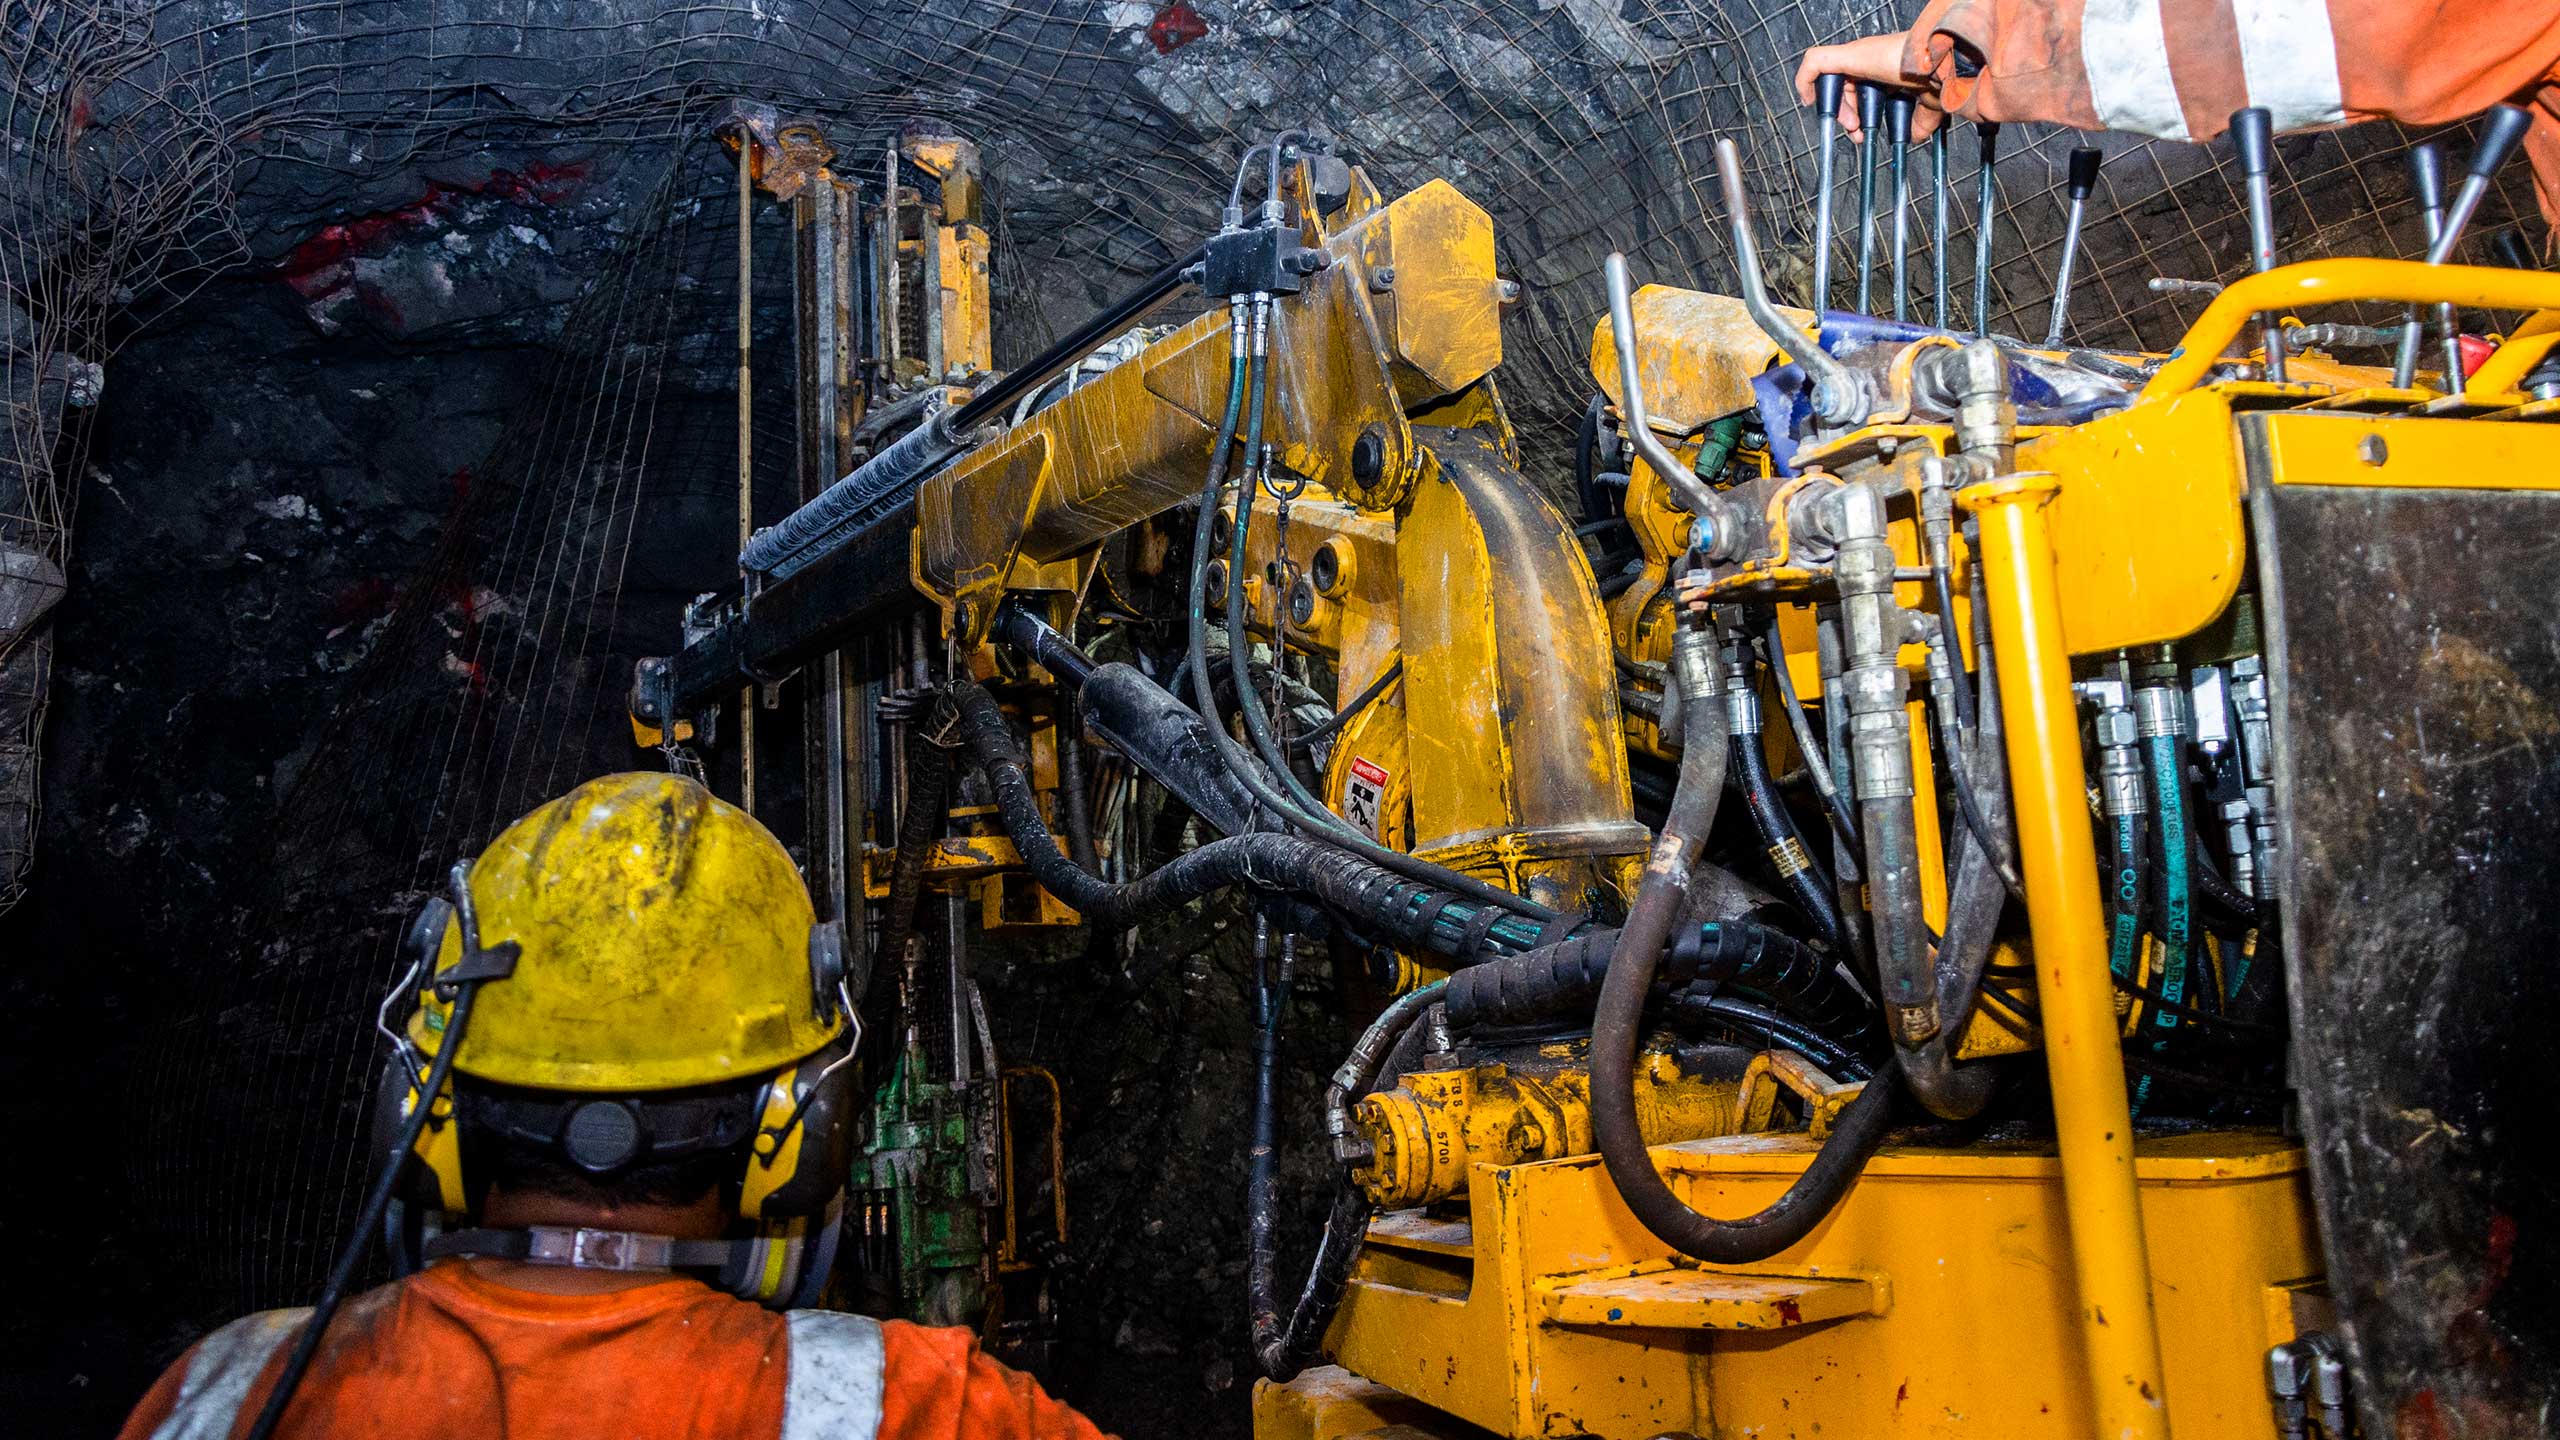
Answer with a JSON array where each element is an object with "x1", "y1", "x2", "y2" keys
[{"x1": 123, "y1": 1261, "x2": 1101, "y2": 1440}]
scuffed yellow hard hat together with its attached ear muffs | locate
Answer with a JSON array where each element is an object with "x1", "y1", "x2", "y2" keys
[{"x1": 374, "y1": 776, "x2": 860, "y2": 1304}]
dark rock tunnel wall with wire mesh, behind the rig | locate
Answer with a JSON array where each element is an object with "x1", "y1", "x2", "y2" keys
[{"x1": 0, "y1": 0, "x2": 2529, "y2": 1432}]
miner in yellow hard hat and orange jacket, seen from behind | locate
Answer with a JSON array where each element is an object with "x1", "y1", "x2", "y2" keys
[{"x1": 123, "y1": 774, "x2": 1101, "y2": 1440}]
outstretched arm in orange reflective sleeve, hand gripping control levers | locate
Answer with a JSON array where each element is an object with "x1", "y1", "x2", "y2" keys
[{"x1": 1795, "y1": 0, "x2": 2560, "y2": 220}]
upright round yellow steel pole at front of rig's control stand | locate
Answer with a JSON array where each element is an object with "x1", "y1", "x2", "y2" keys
[{"x1": 1956, "y1": 474, "x2": 2168, "y2": 1440}]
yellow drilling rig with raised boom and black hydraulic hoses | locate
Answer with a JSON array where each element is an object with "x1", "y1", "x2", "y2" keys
[{"x1": 632, "y1": 109, "x2": 2560, "y2": 1440}]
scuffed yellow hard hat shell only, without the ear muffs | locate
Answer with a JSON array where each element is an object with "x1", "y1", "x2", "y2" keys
[{"x1": 410, "y1": 774, "x2": 845, "y2": 1094}]
